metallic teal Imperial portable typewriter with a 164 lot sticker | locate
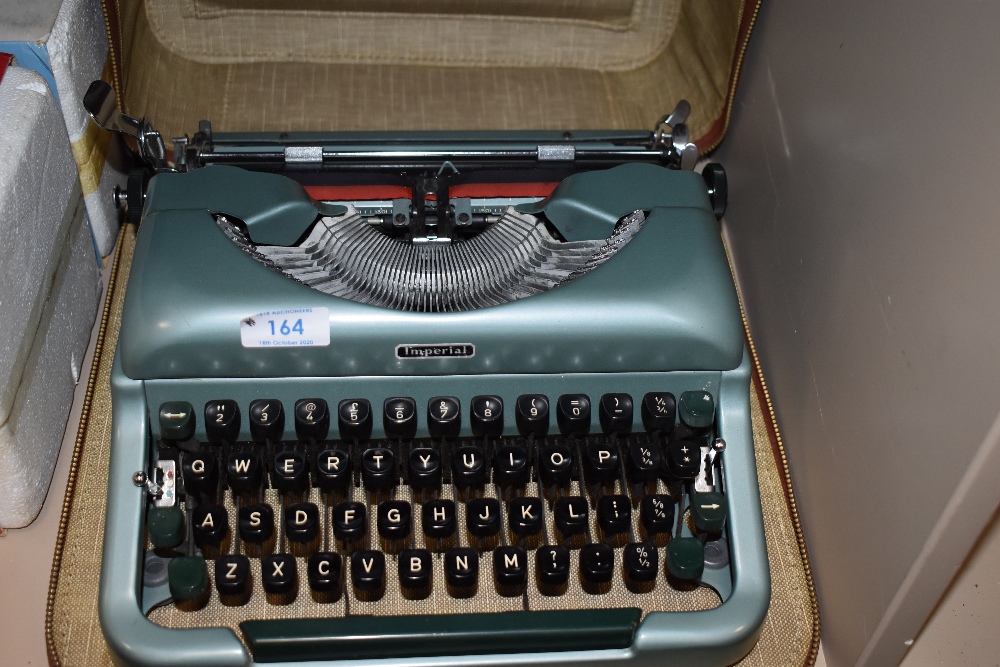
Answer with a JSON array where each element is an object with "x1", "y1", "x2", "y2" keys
[{"x1": 86, "y1": 82, "x2": 770, "y2": 665}]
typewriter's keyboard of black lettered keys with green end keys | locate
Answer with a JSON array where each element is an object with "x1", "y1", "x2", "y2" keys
[{"x1": 144, "y1": 391, "x2": 728, "y2": 640}]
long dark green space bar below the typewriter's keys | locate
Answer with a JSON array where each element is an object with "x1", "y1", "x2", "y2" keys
[{"x1": 240, "y1": 609, "x2": 642, "y2": 662}]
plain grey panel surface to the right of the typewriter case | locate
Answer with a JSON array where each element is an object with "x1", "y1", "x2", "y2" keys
[{"x1": 715, "y1": 0, "x2": 1000, "y2": 666}]
